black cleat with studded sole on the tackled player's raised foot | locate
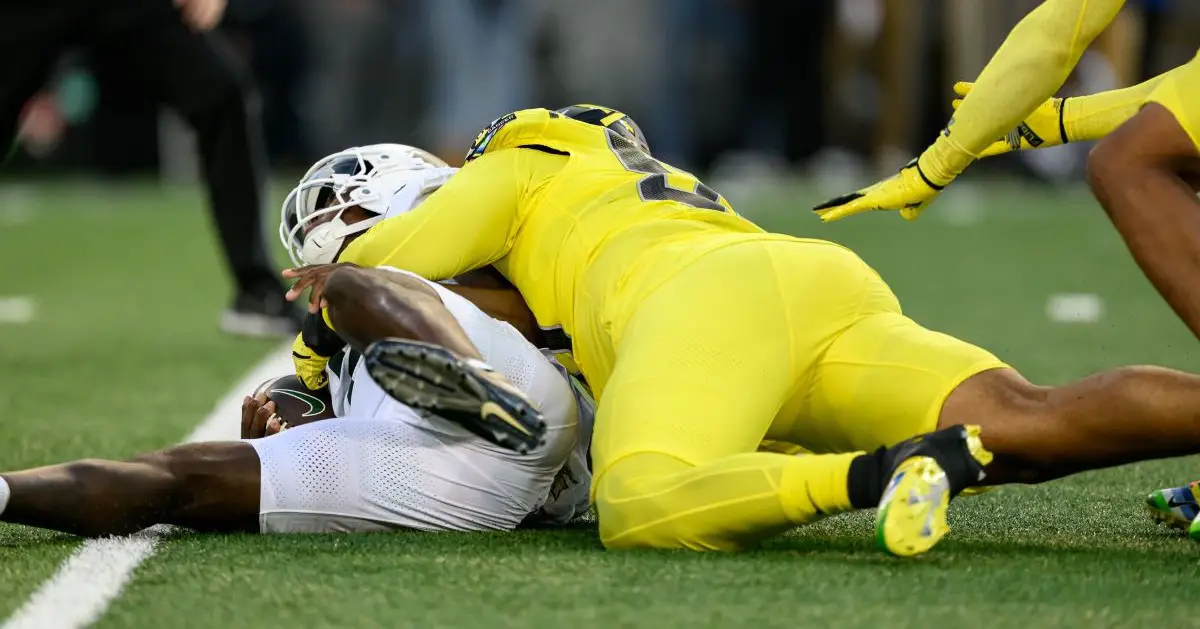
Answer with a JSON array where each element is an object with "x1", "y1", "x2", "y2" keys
[{"x1": 362, "y1": 339, "x2": 546, "y2": 454}]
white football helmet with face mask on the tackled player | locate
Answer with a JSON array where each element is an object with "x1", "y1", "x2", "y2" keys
[{"x1": 280, "y1": 144, "x2": 449, "y2": 265}]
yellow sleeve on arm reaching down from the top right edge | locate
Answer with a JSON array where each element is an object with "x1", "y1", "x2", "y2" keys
[{"x1": 920, "y1": 0, "x2": 1126, "y2": 185}]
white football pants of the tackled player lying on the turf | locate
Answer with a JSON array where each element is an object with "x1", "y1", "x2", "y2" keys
[{"x1": 251, "y1": 269, "x2": 593, "y2": 532}]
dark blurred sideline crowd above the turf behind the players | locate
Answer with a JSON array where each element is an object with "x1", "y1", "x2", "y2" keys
[{"x1": 6, "y1": 0, "x2": 1200, "y2": 181}]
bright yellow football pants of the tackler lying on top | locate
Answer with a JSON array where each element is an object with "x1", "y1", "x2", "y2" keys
[{"x1": 576, "y1": 235, "x2": 1004, "y2": 550}]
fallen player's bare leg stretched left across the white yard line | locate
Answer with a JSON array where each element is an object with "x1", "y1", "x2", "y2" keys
[{"x1": 0, "y1": 442, "x2": 259, "y2": 537}]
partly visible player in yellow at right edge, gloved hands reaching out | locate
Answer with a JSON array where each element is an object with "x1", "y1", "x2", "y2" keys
[{"x1": 816, "y1": 0, "x2": 1200, "y2": 540}]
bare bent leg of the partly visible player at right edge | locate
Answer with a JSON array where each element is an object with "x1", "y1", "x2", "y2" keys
[{"x1": 1087, "y1": 75, "x2": 1200, "y2": 336}]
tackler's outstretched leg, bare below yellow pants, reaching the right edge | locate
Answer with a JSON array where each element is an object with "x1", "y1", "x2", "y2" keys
[{"x1": 791, "y1": 262, "x2": 1200, "y2": 484}]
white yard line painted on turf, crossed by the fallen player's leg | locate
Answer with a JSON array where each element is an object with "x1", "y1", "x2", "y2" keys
[{"x1": 0, "y1": 342, "x2": 293, "y2": 629}]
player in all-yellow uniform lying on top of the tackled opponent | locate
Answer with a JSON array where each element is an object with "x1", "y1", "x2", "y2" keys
[{"x1": 288, "y1": 106, "x2": 1200, "y2": 555}]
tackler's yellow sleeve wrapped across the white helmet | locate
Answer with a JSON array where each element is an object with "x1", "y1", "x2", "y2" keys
[{"x1": 338, "y1": 149, "x2": 535, "y2": 280}]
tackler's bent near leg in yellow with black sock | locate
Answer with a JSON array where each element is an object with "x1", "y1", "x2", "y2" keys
[{"x1": 585, "y1": 242, "x2": 988, "y2": 550}]
